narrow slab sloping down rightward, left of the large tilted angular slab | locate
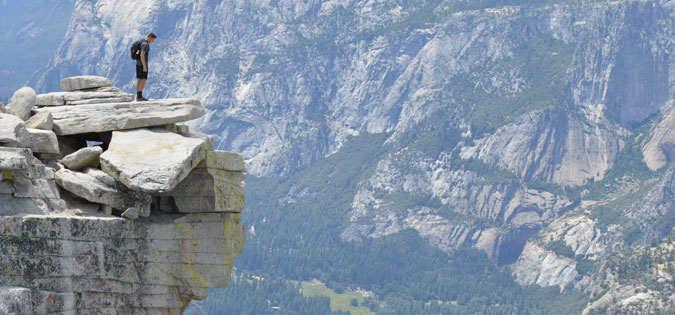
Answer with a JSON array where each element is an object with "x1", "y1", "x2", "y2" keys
[{"x1": 54, "y1": 169, "x2": 151, "y2": 216}]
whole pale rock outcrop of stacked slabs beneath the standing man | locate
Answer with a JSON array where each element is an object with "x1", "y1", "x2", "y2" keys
[{"x1": 0, "y1": 76, "x2": 245, "y2": 314}]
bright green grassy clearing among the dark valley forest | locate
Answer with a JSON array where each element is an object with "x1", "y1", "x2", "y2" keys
[{"x1": 301, "y1": 279, "x2": 375, "y2": 315}]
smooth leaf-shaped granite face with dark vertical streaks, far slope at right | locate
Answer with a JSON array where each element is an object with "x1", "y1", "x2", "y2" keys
[{"x1": 462, "y1": 110, "x2": 622, "y2": 185}]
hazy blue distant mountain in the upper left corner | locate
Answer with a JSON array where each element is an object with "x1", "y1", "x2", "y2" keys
[{"x1": 0, "y1": 0, "x2": 75, "y2": 101}]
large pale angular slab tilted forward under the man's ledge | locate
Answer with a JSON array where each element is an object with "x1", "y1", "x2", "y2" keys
[{"x1": 101, "y1": 128, "x2": 207, "y2": 194}]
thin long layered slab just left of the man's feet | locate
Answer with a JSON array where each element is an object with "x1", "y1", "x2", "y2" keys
[{"x1": 35, "y1": 91, "x2": 134, "y2": 106}]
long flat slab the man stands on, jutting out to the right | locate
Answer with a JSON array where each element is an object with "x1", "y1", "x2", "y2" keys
[{"x1": 37, "y1": 99, "x2": 205, "y2": 136}]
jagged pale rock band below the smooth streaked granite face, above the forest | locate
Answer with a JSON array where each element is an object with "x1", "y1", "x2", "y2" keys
[{"x1": 344, "y1": 149, "x2": 573, "y2": 264}]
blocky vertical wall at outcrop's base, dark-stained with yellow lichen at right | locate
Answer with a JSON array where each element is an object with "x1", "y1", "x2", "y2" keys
[{"x1": 0, "y1": 214, "x2": 245, "y2": 314}]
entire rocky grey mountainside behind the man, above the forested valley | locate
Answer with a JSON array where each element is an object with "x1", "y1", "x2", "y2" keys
[{"x1": 32, "y1": 0, "x2": 675, "y2": 311}]
